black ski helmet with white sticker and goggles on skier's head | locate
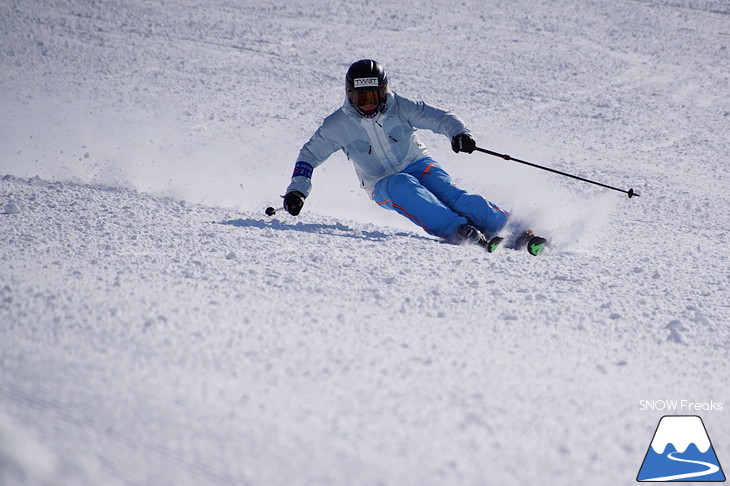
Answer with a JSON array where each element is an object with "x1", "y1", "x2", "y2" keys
[{"x1": 345, "y1": 59, "x2": 388, "y2": 118}]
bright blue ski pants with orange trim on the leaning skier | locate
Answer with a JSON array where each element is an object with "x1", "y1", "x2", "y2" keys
[{"x1": 373, "y1": 157, "x2": 509, "y2": 238}]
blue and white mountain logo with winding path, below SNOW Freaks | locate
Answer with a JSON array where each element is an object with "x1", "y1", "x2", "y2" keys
[{"x1": 636, "y1": 415, "x2": 725, "y2": 483}]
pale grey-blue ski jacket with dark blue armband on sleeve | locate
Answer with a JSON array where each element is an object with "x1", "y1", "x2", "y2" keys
[{"x1": 287, "y1": 92, "x2": 469, "y2": 197}]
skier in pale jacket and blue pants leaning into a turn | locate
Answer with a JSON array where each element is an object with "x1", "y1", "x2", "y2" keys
[{"x1": 284, "y1": 59, "x2": 545, "y2": 255}]
